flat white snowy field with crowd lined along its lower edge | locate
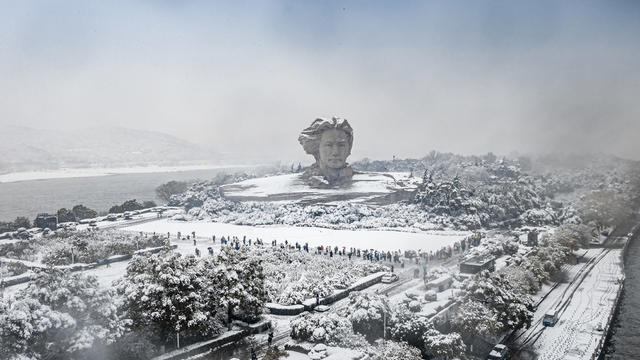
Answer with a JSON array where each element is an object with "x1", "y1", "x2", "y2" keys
[{"x1": 122, "y1": 219, "x2": 471, "y2": 251}]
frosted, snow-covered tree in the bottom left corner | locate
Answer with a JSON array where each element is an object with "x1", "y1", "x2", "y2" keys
[{"x1": 0, "y1": 270, "x2": 128, "y2": 359}]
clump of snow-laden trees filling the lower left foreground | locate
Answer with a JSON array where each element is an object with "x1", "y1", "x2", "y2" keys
[{"x1": 0, "y1": 250, "x2": 266, "y2": 359}]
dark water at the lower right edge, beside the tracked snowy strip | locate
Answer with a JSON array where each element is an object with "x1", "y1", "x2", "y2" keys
[{"x1": 605, "y1": 232, "x2": 640, "y2": 360}]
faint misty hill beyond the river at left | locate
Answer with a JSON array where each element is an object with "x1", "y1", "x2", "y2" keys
[{"x1": 0, "y1": 126, "x2": 216, "y2": 173}]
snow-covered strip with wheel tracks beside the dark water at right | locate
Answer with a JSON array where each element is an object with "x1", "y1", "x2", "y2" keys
[{"x1": 516, "y1": 249, "x2": 624, "y2": 360}]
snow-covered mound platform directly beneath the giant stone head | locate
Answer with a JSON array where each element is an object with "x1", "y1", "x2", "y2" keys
[{"x1": 220, "y1": 173, "x2": 420, "y2": 205}]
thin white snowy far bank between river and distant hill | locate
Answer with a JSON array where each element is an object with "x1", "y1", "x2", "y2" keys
[{"x1": 0, "y1": 165, "x2": 254, "y2": 183}]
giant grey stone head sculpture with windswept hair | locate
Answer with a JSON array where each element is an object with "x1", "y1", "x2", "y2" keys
[{"x1": 298, "y1": 117, "x2": 353, "y2": 188}]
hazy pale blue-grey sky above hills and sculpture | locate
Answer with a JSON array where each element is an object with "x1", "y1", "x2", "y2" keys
[{"x1": 0, "y1": 0, "x2": 640, "y2": 161}]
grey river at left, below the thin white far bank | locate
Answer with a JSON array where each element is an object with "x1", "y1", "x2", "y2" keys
[{"x1": 0, "y1": 168, "x2": 246, "y2": 221}]
